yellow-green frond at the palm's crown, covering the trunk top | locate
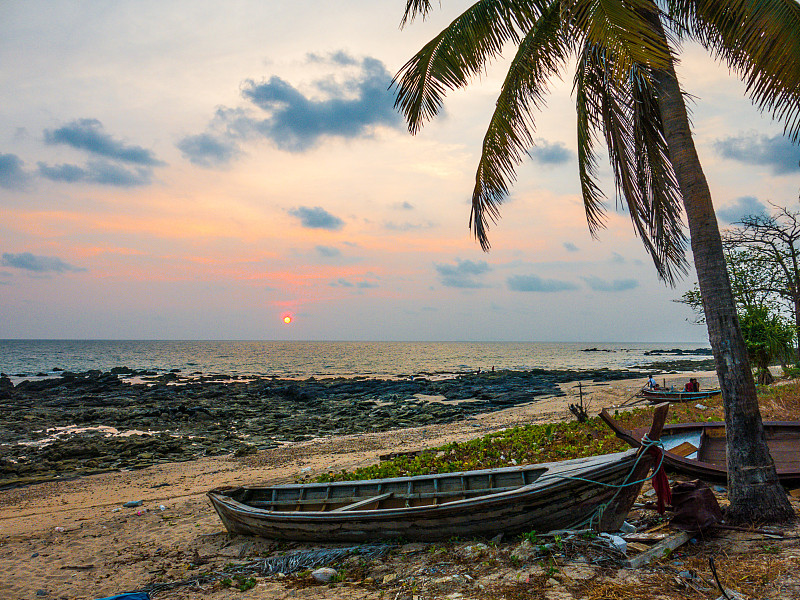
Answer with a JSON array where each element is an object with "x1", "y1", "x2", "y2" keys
[{"x1": 562, "y1": 0, "x2": 669, "y2": 80}]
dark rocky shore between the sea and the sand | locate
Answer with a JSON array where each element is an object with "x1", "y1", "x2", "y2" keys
[{"x1": 0, "y1": 367, "x2": 656, "y2": 488}]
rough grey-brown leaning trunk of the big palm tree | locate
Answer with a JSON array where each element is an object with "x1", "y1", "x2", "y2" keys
[{"x1": 656, "y1": 21, "x2": 795, "y2": 523}]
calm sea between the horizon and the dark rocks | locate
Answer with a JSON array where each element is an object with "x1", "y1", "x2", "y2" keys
[{"x1": 0, "y1": 340, "x2": 709, "y2": 378}]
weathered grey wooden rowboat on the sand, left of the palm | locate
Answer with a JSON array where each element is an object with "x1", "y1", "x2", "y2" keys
[{"x1": 208, "y1": 404, "x2": 668, "y2": 542}]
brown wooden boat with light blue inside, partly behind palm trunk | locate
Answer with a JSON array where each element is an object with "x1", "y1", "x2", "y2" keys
[{"x1": 600, "y1": 409, "x2": 800, "y2": 483}]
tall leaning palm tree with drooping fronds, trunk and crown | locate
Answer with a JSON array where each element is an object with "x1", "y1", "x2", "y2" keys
[{"x1": 394, "y1": 0, "x2": 800, "y2": 522}]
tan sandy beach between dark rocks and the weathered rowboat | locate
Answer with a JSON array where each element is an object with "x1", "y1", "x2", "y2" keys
[{"x1": 0, "y1": 373, "x2": 800, "y2": 600}]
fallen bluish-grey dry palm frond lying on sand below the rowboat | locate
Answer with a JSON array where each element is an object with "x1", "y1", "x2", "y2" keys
[{"x1": 136, "y1": 544, "x2": 391, "y2": 594}]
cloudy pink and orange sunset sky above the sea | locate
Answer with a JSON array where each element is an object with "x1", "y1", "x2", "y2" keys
[{"x1": 0, "y1": 0, "x2": 800, "y2": 343}]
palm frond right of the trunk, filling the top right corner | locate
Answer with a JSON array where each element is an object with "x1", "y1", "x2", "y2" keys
[{"x1": 666, "y1": 0, "x2": 800, "y2": 142}]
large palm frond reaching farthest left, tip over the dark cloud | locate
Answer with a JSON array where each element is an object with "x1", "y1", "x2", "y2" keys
[{"x1": 392, "y1": 0, "x2": 549, "y2": 133}]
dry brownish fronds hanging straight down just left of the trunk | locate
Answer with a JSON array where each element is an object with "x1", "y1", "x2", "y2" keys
[{"x1": 576, "y1": 43, "x2": 687, "y2": 285}]
